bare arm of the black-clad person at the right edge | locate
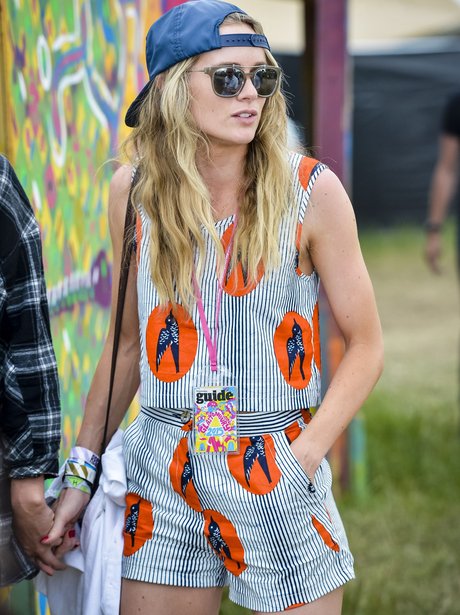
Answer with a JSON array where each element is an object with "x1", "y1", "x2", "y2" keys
[{"x1": 425, "y1": 92, "x2": 460, "y2": 276}]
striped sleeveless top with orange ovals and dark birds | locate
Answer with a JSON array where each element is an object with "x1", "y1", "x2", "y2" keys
[{"x1": 136, "y1": 153, "x2": 326, "y2": 412}]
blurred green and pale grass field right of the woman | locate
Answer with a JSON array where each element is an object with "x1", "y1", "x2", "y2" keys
[{"x1": 221, "y1": 226, "x2": 460, "y2": 615}]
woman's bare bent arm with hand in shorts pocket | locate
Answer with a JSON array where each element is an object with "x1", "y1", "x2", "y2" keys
[{"x1": 292, "y1": 170, "x2": 383, "y2": 477}]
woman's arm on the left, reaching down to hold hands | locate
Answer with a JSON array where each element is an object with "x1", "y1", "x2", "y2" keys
[{"x1": 43, "y1": 167, "x2": 140, "y2": 557}]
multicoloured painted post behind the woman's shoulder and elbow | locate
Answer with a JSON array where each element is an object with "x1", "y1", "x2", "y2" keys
[{"x1": 305, "y1": 0, "x2": 367, "y2": 497}]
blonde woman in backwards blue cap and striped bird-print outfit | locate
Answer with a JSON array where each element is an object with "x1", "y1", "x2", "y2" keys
[{"x1": 50, "y1": 0, "x2": 382, "y2": 615}]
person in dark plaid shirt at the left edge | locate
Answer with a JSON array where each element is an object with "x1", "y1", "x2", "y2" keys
[{"x1": 0, "y1": 155, "x2": 64, "y2": 586}]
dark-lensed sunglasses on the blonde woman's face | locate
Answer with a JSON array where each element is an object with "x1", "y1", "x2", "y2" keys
[{"x1": 189, "y1": 64, "x2": 281, "y2": 98}]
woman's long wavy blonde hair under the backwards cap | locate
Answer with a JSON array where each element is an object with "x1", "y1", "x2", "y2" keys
[{"x1": 122, "y1": 13, "x2": 291, "y2": 307}]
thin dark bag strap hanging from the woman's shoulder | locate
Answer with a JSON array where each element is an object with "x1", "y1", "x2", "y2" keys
[{"x1": 92, "y1": 170, "x2": 138, "y2": 493}]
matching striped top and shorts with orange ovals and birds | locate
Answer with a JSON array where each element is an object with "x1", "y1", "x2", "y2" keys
[{"x1": 123, "y1": 154, "x2": 354, "y2": 613}]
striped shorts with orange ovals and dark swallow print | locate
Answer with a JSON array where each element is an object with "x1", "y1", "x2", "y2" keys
[{"x1": 122, "y1": 408, "x2": 354, "y2": 613}]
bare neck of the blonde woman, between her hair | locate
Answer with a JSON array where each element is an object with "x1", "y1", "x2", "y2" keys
[{"x1": 197, "y1": 149, "x2": 246, "y2": 220}]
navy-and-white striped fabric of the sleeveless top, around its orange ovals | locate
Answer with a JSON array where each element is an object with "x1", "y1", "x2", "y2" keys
[{"x1": 137, "y1": 154, "x2": 325, "y2": 412}]
